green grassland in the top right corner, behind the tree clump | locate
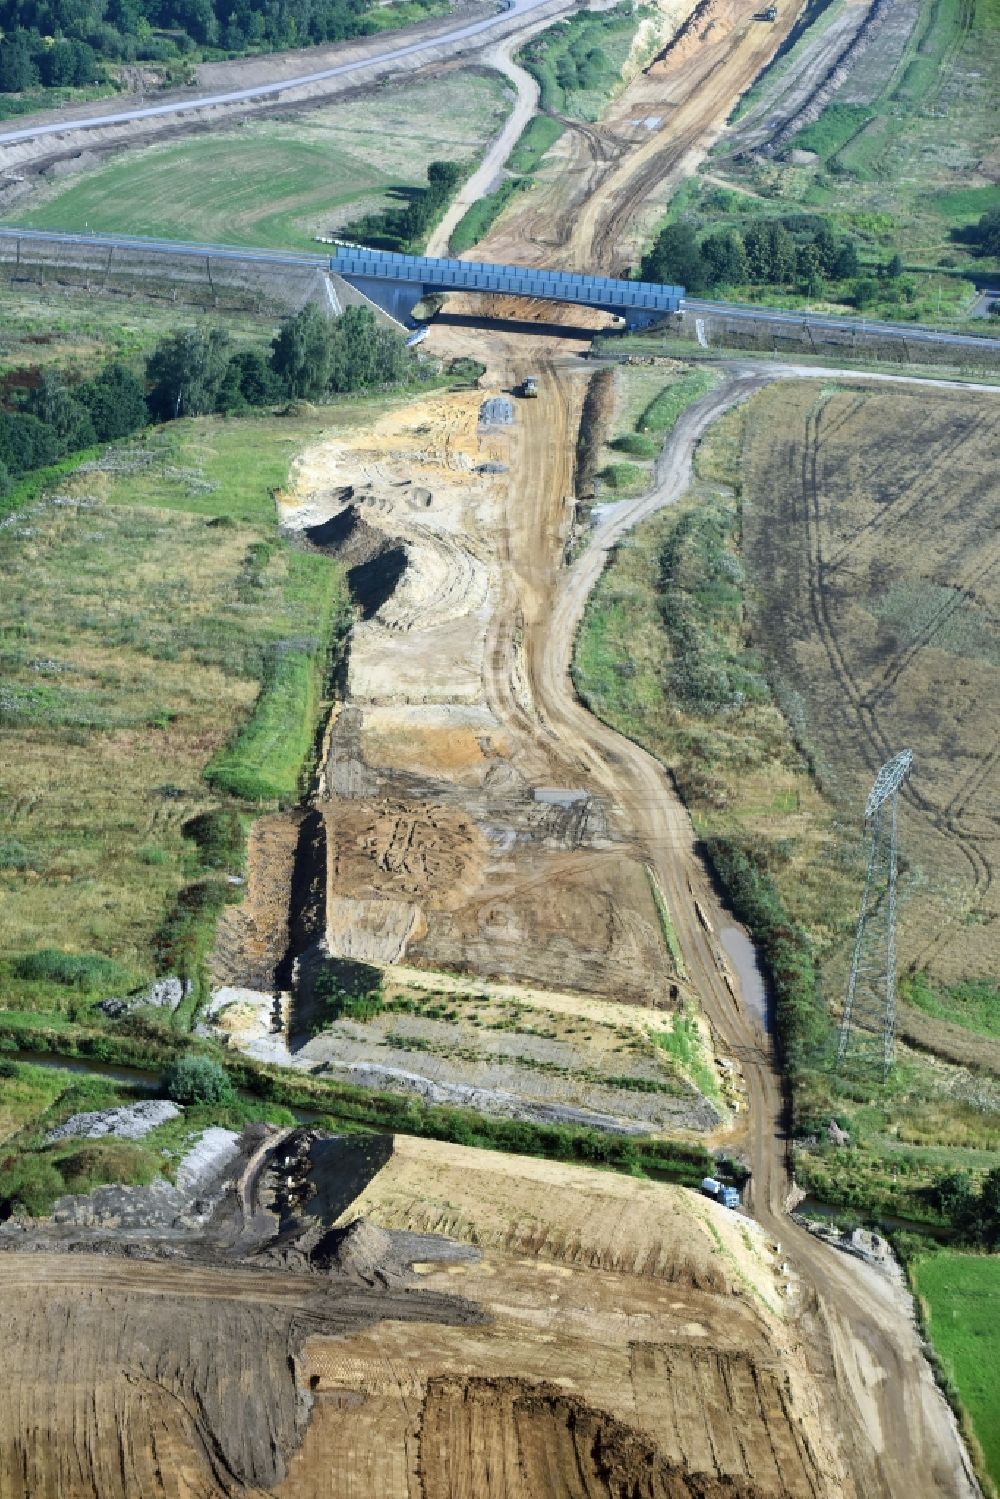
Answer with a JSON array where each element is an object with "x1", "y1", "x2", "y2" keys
[{"x1": 656, "y1": 0, "x2": 1000, "y2": 327}]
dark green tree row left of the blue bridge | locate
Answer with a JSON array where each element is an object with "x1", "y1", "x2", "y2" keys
[{"x1": 0, "y1": 306, "x2": 415, "y2": 495}]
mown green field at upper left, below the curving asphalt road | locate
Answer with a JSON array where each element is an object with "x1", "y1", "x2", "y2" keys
[{"x1": 3, "y1": 72, "x2": 507, "y2": 249}]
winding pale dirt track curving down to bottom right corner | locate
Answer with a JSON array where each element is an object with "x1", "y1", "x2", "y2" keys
[{"x1": 528, "y1": 365, "x2": 978, "y2": 1499}]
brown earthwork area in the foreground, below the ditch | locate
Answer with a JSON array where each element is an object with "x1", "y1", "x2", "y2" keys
[{"x1": 0, "y1": 1126, "x2": 850, "y2": 1499}]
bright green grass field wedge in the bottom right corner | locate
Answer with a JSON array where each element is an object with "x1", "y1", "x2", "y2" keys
[{"x1": 912, "y1": 1252, "x2": 1000, "y2": 1487}]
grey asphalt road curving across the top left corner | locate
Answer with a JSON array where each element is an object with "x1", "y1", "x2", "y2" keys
[{"x1": 0, "y1": 0, "x2": 547, "y2": 145}]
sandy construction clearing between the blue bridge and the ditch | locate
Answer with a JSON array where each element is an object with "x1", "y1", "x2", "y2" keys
[{"x1": 205, "y1": 378, "x2": 741, "y2": 1135}]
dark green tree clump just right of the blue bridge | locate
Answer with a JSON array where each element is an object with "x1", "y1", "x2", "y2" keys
[{"x1": 642, "y1": 214, "x2": 903, "y2": 304}]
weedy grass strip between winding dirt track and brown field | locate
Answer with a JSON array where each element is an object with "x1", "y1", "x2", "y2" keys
[{"x1": 574, "y1": 368, "x2": 1000, "y2": 1222}]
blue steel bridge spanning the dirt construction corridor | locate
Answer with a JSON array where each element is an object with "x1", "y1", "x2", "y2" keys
[{"x1": 330, "y1": 244, "x2": 684, "y2": 328}]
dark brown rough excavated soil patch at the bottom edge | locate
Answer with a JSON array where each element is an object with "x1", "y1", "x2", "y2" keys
[{"x1": 420, "y1": 1376, "x2": 781, "y2": 1499}]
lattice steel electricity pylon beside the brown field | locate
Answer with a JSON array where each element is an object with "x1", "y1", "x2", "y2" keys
[{"x1": 837, "y1": 750, "x2": 913, "y2": 1078}]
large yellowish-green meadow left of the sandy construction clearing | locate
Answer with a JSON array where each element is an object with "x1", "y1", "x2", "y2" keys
[{"x1": 0, "y1": 402, "x2": 359, "y2": 1015}]
